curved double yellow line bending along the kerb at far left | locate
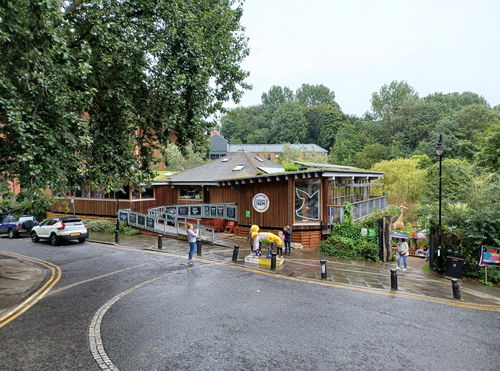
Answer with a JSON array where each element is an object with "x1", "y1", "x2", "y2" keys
[{"x1": 0, "y1": 250, "x2": 61, "y2": 327}]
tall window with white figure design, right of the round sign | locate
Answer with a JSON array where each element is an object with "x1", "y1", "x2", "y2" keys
[{"x1": 295, "y1": 179, "x2": 321, "y2": 222}]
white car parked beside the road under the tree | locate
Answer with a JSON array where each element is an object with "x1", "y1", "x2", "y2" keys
[{"x1": 31, "y1": 217, "x2": 89, "y2": 246}]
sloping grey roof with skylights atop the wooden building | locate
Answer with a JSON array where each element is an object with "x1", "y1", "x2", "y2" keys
[{"x1": 170, "y1": 152, "x2": 284, "y2": 184}]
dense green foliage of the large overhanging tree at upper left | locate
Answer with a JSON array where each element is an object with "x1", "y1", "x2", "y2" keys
[{"x1": 0, "y1": 0, "x2": 248, "y2": 196}]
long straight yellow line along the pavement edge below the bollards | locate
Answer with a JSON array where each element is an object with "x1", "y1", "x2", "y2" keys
[{"x1": 92, "y1": 245, "x2": 500, "y2": 312}]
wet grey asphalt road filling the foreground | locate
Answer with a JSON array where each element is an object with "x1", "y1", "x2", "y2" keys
[{"x1": 0, "y1": 238, "x2": 500, "y2": 370}]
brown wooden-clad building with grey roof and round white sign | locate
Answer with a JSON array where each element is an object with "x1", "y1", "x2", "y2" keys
[{"x1": 53, "y1": 152, "x2": 386, "y2": 248}]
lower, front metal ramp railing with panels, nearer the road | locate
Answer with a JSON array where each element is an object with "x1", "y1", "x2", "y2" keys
[{"x1": 118, "y1": 209, "x2": 215, "y2": 244}]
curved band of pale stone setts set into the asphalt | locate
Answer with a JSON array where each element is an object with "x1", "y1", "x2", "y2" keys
[{"x1": 89, "y1": 268, "x2": 189, "y2": 371}]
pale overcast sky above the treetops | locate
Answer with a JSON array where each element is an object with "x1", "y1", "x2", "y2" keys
[{"x1": 228, "y1": 0, "x2": 500, "y2": 115}]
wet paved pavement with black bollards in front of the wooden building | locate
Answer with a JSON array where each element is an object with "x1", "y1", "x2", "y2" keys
[{"x1": 91, "y1": 232, "x2": 500, "y2": 310}]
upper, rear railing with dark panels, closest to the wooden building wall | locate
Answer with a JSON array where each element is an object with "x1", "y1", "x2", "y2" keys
[{"x1": 148, "y1": 203, "x2": 238, "y2": 221}]
